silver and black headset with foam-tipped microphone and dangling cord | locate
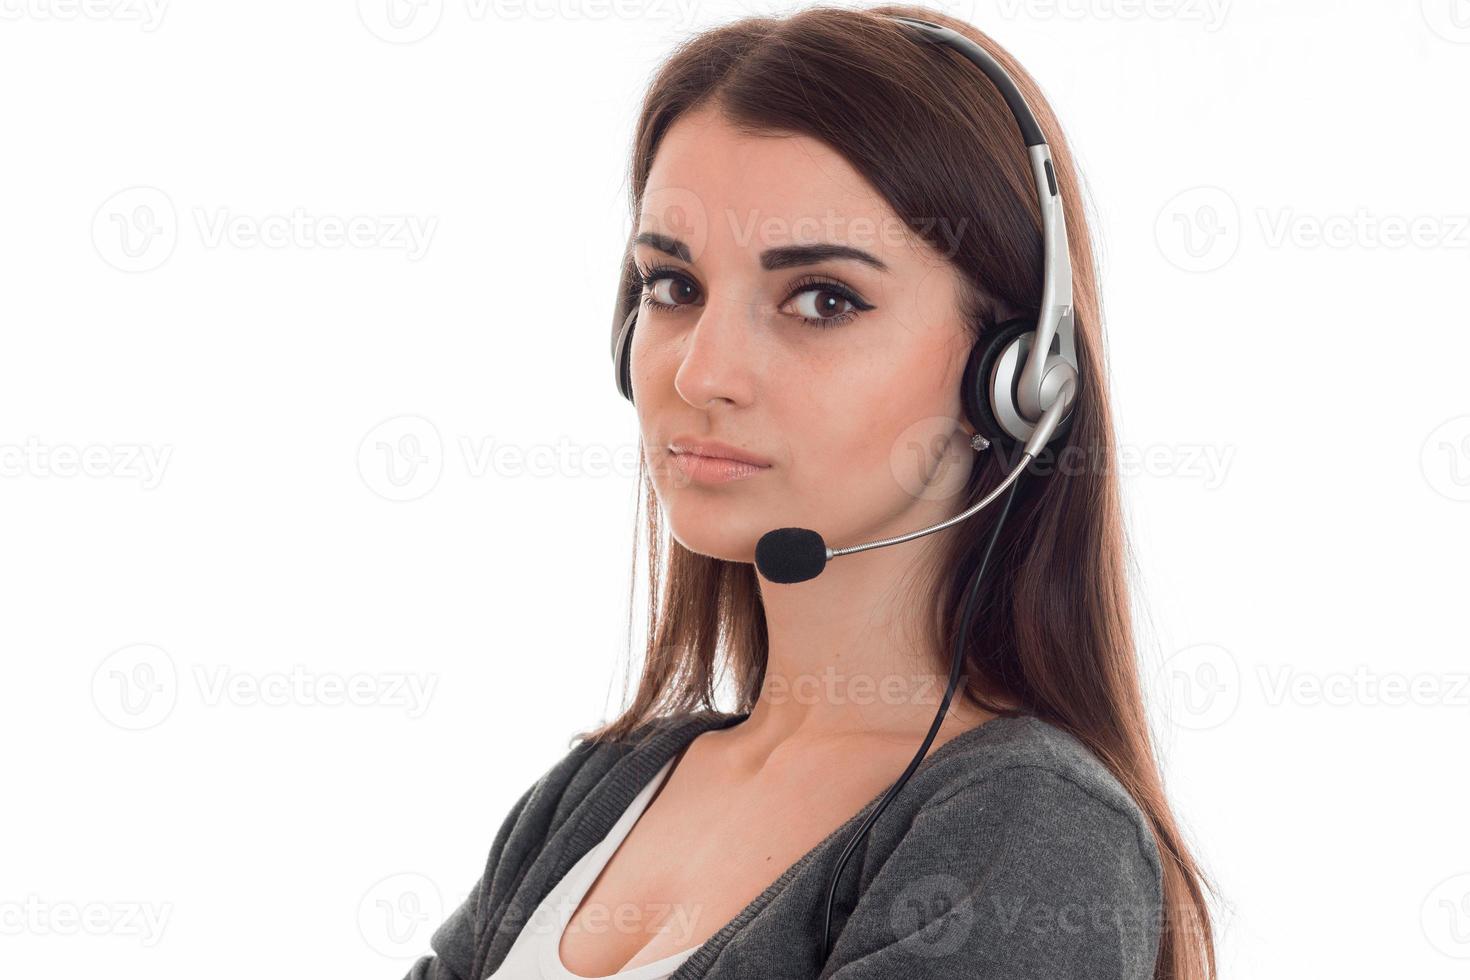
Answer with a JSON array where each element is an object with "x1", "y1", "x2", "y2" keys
[{"x1": 612, "y1": 15, "x2": 1080, "y2": 962}]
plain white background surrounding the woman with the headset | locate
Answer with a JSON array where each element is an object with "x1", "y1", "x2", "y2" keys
[{"x1": 0, "y1": 0, "x2": 1470, "y2": 980}]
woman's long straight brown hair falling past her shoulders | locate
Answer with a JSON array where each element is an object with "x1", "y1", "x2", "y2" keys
[{"x1": 581, "y1": 4, "x2": 1216, "y2": 980}]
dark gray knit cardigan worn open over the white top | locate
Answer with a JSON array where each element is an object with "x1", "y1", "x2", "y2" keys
[{"x1": 406, "y1": 711, "x2": 1161, "y2": 980}]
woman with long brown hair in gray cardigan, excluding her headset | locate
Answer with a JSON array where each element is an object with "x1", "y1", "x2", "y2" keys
[{"x1": 409, "y1": 6, "x2": 1214, "y2": 980}]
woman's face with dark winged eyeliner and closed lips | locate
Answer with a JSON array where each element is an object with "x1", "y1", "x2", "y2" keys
[{"x1": 631, "y1": 110, "x2": 975, "y2": 561}]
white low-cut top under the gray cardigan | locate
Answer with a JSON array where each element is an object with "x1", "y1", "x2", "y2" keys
[{"x1": 485, "y1": 757, "x2": 698, "y2": 980}]
